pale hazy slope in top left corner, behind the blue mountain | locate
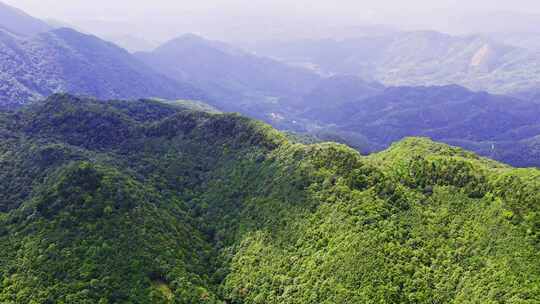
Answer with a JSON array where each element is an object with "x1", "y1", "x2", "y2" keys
[{"x1": 0, "y1": 2, "x2": 52, "y2": 36}]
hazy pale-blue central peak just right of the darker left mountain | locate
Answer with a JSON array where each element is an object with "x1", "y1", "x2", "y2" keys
[{"x1": 136, "y1": 34, "x2": 320, "y2": 119}]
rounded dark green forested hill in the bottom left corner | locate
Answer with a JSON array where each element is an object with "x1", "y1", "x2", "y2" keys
[{"x1": 0, "y1": 162, "x2": 219, "y2": 303}]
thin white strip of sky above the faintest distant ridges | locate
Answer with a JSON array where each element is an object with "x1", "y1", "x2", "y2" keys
[{"x1": 5, "y1": 0, "x2": 540, "y2": 19}]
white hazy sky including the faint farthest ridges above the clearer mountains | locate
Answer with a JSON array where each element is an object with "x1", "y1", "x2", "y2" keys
[{"x1": 4, "y1": 0, "x2": 540, "y2": 45}]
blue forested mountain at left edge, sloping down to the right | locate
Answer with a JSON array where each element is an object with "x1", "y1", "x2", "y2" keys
[{"x1": 0, "y1": 28, "x2": 205, "y2": 106}]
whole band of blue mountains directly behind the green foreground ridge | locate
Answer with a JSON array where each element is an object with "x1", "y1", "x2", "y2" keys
[{"x1": 0, "y1": 7, "x2": 540, "y2": 166}]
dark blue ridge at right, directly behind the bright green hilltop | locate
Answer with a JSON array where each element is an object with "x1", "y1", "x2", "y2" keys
[{"x1": 296, "y1": 85, "x2": 540, "y2": 166}]
